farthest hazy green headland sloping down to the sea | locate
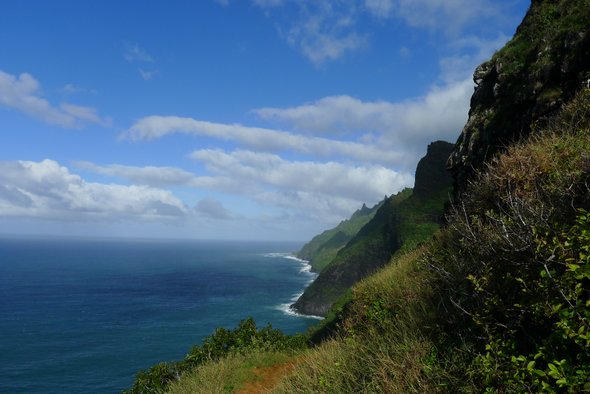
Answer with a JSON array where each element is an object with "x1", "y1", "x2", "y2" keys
[{"x1": 297, "y1": 200, "x2": 385, "y2": 272}]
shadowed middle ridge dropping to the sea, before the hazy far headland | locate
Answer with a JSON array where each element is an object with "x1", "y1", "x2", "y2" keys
[{"x1": 293, "y1": 141, "x2": 453, "y2": 316}]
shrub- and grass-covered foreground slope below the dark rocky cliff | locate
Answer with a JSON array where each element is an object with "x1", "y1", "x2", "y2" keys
[{"x1": 275, "y1": 90, "x2": 590, "y2": 393}]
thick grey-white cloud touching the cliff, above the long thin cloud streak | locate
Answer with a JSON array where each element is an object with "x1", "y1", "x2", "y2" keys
[{"x1": 254, "y1": 78, "x2": 473, "y2": 156}]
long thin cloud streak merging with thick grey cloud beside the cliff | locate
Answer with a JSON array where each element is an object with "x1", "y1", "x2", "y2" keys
[{"x1": 123, "y1": 77, "x2": 474, "y2": 171}]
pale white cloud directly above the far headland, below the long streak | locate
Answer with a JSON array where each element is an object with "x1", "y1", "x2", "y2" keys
[{"x1": 191, "y1": 149, "x2": 413, "y2": 225}]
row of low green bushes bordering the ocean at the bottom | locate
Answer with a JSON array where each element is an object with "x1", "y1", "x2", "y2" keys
[{"x1": 125, "y1": 318, "x2": 307, "y2": 394}]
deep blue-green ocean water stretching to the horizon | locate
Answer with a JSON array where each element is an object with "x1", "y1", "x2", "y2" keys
[{"x1": 0, "y1": 238, "x2": 315, "y2": 393}]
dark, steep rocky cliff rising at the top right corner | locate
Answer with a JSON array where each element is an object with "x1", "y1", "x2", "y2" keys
[{"x1": 448, "y1": 0, "x2": 590, "y2": 193}]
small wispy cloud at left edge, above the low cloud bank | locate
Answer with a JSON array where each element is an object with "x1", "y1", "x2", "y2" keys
[{"x1": 0, "y1": 70, "x2": 109, "y2": 128}]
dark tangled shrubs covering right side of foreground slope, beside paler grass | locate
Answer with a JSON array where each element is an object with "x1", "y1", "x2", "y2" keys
[{"x1": 426, "y1": 90, "x2": 590, "y2": 392}]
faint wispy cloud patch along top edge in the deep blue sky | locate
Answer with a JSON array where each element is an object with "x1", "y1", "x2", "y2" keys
[{"x1": 253, "y1": 0, "x2": 505, "y2": 66}]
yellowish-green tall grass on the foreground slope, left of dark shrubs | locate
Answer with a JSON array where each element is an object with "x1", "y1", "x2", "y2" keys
[{"x1": 273, "y1": 248, "x2": 450, "y2": 393}]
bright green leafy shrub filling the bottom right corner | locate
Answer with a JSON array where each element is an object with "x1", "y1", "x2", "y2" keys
[{"x1": 471, "y1": 210, "x2": 590, "y2": 393}]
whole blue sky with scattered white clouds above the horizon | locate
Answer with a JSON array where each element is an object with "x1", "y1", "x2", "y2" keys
[{"x1": 0, "y1": 0, "x2": 529, "y2": 241}]
